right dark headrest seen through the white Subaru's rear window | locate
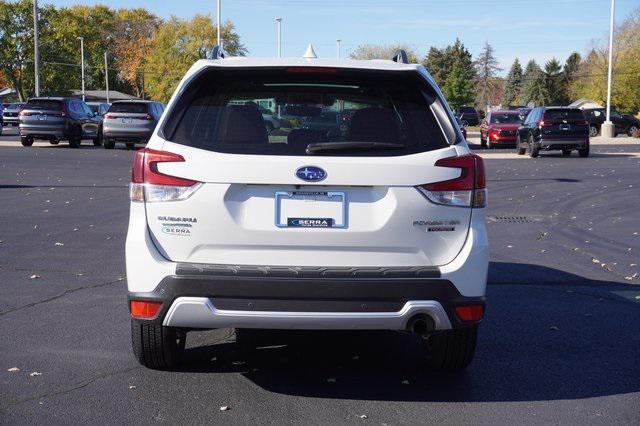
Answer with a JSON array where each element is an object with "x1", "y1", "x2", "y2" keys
[{"x1": 349, "y1": 108, "x2": 400, "y2": 142}]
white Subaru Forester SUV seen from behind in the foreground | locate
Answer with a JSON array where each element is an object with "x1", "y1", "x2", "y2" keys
[{"x1": 126, "y1": 51, "x2": 489, "y2": 371}]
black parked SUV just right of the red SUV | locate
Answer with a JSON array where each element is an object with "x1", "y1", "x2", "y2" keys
[{"x1": 516, "y1": 107, "x2": 589, "y2": 158}]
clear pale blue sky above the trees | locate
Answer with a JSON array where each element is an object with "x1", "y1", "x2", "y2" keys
[{"x1": 46, "y1": 0, "x2": 640, "y2": 75}]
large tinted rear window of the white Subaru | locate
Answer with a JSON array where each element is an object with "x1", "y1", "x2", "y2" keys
[{"x1": 163, "y1": 68, "x2": 455, "y2": 156}]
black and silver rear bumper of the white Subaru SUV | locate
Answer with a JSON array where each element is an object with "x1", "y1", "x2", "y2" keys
[{"x1": 129, "y1": 264, "x2": 484, "y2": 330}]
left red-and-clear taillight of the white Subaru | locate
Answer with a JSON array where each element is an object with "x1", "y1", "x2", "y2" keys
[{"x1": 129, "y1": 148, "x2": 201, "y2": 202}]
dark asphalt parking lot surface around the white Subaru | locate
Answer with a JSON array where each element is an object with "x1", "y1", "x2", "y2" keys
[{"x1": 0, "y1": 127, "x2": 640, "y2": 424}]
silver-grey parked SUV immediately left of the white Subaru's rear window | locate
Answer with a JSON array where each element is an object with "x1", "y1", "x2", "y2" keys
[{"x1": 102, "y1": 101, "x2": 164, "y2": 149}]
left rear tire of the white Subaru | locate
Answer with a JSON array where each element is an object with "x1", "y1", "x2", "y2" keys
[{"x1": 131, "y1": 319, "x2": 187, "y2": 370}]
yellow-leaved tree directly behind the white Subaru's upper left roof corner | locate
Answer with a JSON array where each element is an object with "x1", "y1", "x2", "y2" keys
[{"x1": 144, "y1": 15, "x2": 247, "y2": 102}]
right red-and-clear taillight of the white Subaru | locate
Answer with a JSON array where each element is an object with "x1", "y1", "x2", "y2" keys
[{"x1": 417, "y1": 154, "x2": 487, "y2": 208}]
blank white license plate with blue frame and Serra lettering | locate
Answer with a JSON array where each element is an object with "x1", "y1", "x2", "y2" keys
[{"x1": 275, "y1": 191, "x2": 347, "y2": 228}]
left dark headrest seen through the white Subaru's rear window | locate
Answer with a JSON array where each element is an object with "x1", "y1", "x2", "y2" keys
[{"x1": 218, "y1": 104, "x2": 269, "y2": 144}]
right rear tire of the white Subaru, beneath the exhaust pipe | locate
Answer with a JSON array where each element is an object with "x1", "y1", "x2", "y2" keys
[{"x1": 425, "y1": 325, "x2": 478, "y2": 373}]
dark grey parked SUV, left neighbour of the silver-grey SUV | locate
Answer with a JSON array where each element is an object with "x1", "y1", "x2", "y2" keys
[{"x1": 20, "y1": 98, "x2": 100, "y2": 148}]
